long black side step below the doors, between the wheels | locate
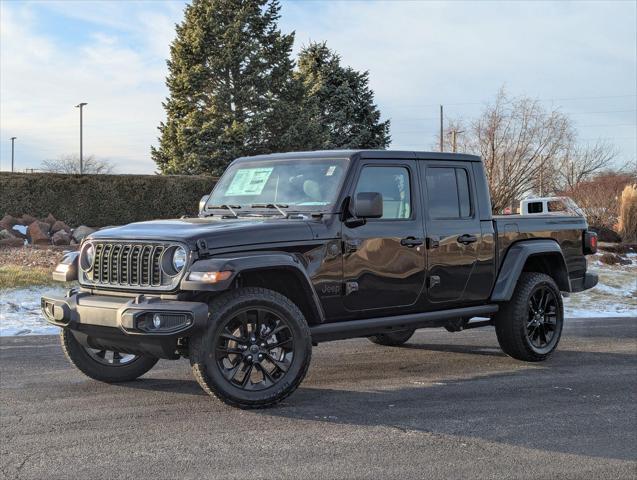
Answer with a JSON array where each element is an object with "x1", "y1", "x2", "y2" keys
[{"x1": 310, "y1": 305, "x2": 498, "y2": 343}]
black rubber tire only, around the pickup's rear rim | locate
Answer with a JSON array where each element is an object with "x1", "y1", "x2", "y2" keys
[{"x1": 495, "y1": 272, "x2": 564, "y2": 362}]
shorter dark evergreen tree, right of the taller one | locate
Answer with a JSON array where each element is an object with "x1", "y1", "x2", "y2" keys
[{"x1": 297, "y1": 43, "x2": 391, "y2": 149}]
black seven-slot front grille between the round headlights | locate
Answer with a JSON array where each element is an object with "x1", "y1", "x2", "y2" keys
[{"x1": 89, "y1": 243, "x2": 169, "y2": 287}]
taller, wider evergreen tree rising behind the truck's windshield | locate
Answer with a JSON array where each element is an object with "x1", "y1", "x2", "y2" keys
[{"x1": 151, "y1": 0, "x2": 312, "y2": 174}]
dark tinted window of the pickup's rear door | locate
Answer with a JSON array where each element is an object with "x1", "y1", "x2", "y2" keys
[{"x1": 426, "y1": 167, "x2": 471, "y2": 219}]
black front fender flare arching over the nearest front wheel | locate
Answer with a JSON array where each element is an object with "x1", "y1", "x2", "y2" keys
[{"x1": 180, "y1": 252, "x2": 325, "y2": 323}]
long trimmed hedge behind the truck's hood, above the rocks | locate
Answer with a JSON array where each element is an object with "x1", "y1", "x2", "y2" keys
[{"x1": 0, "y1": 172, "x2": 216, "y2": 227}]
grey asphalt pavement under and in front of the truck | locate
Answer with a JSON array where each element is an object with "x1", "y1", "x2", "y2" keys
[{"x1": 0, "y1": 318, "x2": 637, "y2": 479}]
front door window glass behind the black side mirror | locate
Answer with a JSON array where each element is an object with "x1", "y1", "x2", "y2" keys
[{"x1": 354, "y1": 167, "x2": 411, "y2": 220}]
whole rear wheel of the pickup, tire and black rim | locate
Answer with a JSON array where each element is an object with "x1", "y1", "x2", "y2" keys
[{"x1": 495, "y1": 272, "x2": 564, "y2": 362}]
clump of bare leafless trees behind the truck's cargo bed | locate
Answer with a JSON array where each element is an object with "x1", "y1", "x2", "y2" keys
[{"x1": 443, "y1": 89, "x2": 617, "y2": 212}]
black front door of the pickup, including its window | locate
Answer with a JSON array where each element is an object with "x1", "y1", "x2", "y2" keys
[{"x1": 343, "y1": 160, "x2": 425, "y2": 313}]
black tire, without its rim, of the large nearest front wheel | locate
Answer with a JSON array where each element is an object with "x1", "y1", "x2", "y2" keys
[{"x1": 190, "y1": 287, "x2": 312, "y2": 409}]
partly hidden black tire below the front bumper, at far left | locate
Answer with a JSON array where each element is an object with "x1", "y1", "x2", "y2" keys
[{"x1": 60, "y1": 328, "x2": 159, "y2": 383}]
